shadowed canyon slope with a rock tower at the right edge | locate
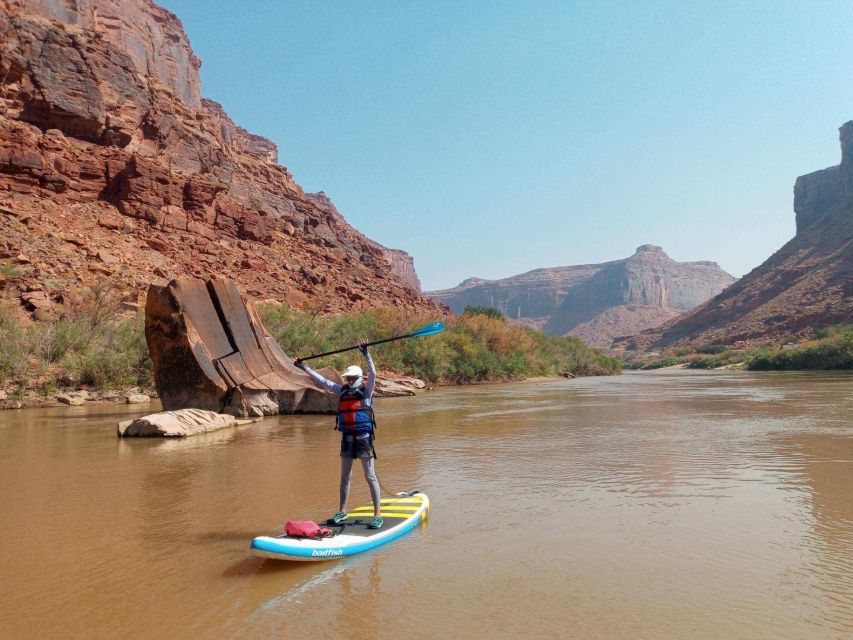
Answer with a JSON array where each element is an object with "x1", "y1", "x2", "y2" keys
[{"x1": 619, "y1": 121, "x2": 853, "y2": 349}]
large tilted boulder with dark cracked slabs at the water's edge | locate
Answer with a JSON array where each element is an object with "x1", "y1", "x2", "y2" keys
[{"x1": 145, "y1": 278, "x2": 337, "y2": 416}]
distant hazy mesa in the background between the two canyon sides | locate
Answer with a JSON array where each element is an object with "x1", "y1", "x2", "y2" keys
[{"x1": 426, "y1": 244, "x2": 734, "y2": 347}]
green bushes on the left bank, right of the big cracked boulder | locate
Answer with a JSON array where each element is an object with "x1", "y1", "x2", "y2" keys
[{"x1": 259, "y1": 305, "x2": 621, "y2": 384}]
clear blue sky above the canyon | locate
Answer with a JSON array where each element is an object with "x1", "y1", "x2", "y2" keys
[{"x1": 162, "y1": 0, "x2": 853, "y2": 289}]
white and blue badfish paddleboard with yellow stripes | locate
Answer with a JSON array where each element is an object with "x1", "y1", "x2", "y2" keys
[{"x1": 252, "y1": 491, "x2": 429, "y2": 561}]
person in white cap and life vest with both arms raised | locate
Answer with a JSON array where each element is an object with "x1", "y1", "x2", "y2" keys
[{"x1": 294, "y1": 340, "x2": 382, "y2": 529}]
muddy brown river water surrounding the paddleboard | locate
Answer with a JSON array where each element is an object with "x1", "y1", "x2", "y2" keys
[{"x1": 0, "y1": 371, "x2": 853, "y2": 639}]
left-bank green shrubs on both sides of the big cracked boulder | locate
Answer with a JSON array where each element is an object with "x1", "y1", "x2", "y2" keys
[{"x1": 0, "y1": 298, "x2": 621, "y2": 394}]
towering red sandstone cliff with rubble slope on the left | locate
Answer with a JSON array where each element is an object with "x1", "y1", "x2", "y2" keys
[{"x1": 0, "y1": 0, "x2": 440, "y2": 311}]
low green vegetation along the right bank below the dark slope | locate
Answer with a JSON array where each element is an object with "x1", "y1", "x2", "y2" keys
[{"x1": 625, "y1": 324, "x2": 853, "y2": 371}]
